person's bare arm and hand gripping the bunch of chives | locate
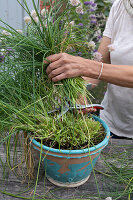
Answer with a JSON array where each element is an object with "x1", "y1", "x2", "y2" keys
[{"x1": 44, "y1": 37, "x2": 133, "y2": 88}]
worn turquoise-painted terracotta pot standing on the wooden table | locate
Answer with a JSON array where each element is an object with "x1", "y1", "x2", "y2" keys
[{"x1": 31, "y1": 116, "x2": 110, "y2": 187}]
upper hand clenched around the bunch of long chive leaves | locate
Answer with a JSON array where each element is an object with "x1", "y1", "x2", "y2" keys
[{"x1": 44, "y1": 53, "x2": 89, "y2": 82}]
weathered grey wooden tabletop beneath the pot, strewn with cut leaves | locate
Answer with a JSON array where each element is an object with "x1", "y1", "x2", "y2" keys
[{"x1": 0, "y1": 139, "x2": 133, "y2": 200}]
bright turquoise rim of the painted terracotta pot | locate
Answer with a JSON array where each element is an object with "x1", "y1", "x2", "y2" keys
[{"x1": 30, "y1": 115, "x2": 110, "y2": 154}]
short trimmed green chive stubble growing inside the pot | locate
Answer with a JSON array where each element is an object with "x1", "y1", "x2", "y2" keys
[{"x1": 17, "y1": 112, "x2": 105, "y2": 149}]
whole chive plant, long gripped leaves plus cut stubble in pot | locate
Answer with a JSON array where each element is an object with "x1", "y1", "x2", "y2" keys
[{"x1": 0, "y1": 0, "x2": 104, "y2": 148}]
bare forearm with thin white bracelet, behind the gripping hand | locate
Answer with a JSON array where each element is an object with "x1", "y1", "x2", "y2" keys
[{"x1": 85, "y1": 61, "x2": 133, "y2": 88}]
